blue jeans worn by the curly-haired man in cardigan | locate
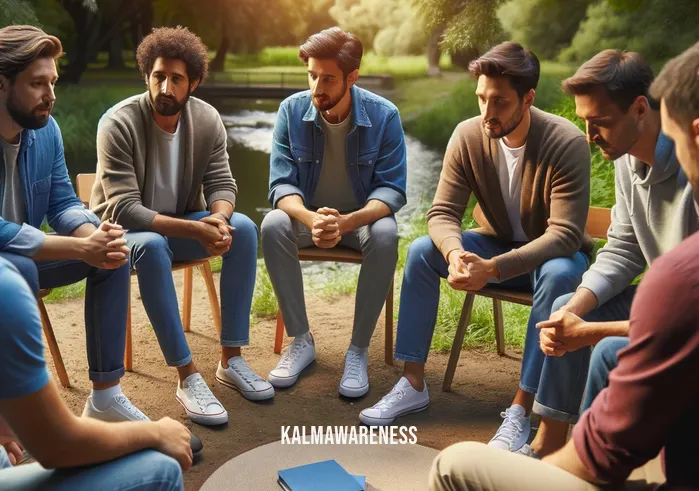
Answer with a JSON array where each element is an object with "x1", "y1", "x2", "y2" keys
[{"x1": 125, "y1": 211, "x2": 257, "y2": 367}]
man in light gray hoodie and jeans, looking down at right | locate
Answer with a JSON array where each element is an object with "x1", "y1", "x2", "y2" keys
[{"x1": 523, "y1": 50, "x2": 699, "y2": 456}]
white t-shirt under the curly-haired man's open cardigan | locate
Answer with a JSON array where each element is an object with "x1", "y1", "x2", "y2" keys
[{"x1": 148, "y1": 120, "x2": 184, "y2": 214}]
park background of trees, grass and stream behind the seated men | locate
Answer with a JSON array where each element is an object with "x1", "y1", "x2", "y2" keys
[{"x1": 0, "y1": 0, "x2": 699, "y2": 487}]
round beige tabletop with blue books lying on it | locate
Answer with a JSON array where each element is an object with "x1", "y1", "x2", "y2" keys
[{"x1": 201, "y1": 441, "x2": 439, "y2": 491}]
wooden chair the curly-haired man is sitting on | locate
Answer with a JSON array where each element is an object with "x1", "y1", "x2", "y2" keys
[{"x1": 76, "y1": 174, "x2": 221, "y2": 371}]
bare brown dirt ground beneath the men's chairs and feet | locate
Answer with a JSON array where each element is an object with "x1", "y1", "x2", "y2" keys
[{"x1": 46, "y1": 272, "x2": 521, "y2": 490}]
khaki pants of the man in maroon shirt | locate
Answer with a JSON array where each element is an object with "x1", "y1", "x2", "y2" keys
[{"x1": 429, "y1": 442, "x2": 665, "y2": 491}]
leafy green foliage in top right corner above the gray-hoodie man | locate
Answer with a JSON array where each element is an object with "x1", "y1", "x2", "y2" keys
[{"x1": 559, "y1": 0, "x2": 699, "y2": 63}]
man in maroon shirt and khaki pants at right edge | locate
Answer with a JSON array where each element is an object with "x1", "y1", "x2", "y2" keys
[{"x1": 430, "y1": 39, "x2": 699, "y2": 491}]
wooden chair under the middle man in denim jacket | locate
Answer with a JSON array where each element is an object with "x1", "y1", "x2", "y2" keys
[{"x1": 274, "y1": 246, "x2": 393, "y2": 365}]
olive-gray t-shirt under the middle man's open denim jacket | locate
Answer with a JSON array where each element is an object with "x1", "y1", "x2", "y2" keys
[{"x1": 311, "y1": 114, "x2": 359, "y2": 212}]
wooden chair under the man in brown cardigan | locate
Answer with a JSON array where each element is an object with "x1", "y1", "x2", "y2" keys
[{"x1": 442, "y1": 205, "x2": 612, "y2": 392}]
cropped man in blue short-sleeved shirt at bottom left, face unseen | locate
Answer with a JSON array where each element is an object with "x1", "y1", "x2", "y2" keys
[{"x1": 0, "y1": 258, "x2": 192, "y2": 491}]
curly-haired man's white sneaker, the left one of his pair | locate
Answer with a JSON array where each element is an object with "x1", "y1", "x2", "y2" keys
[{"x1": 176, "y1": 373, "x2": 228, "y2": 426}]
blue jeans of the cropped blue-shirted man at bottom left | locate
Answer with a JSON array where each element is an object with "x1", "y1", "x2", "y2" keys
[{"x1": 0, "y1": 452, "x2": 184, "y2": 491}]
